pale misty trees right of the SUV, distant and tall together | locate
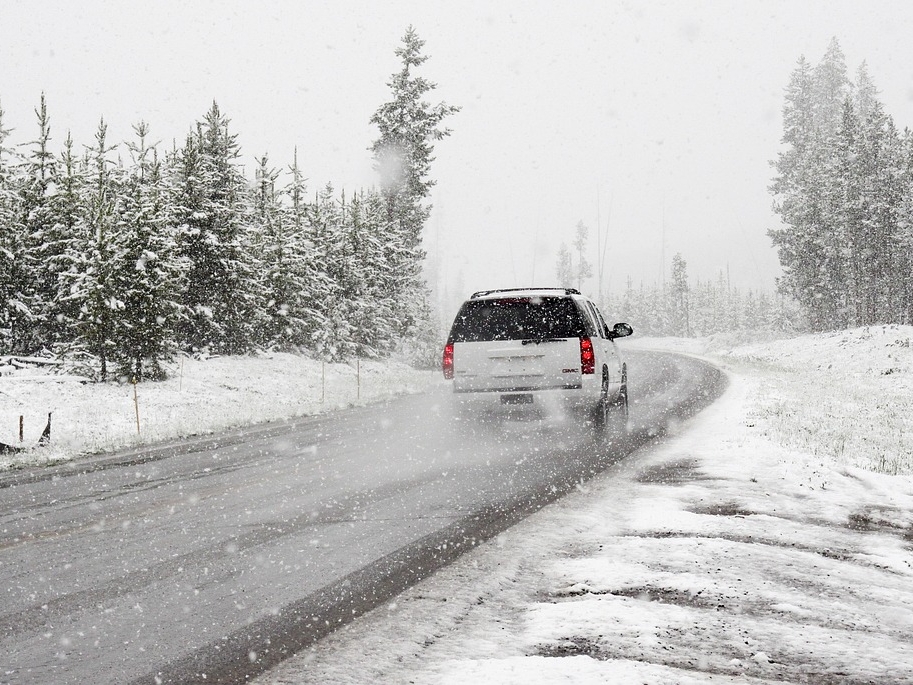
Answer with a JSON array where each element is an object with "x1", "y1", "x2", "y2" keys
[{"x1": 557, "y1": 39, "x2": 913, "y2": 336}]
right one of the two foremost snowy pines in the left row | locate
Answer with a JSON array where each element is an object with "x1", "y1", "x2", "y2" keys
[{"x1": 111, "y1": 122, "x2": 184, "y2": 382}]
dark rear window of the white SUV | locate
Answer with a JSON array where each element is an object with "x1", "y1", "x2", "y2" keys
[{"x1": 450, "y1": 297, "x2": 587, "y2": 342}]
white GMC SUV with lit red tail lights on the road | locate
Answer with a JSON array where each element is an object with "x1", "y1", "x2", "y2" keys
[{"x1": 443, "y1": 288, "x2": 633, "y2": 429}]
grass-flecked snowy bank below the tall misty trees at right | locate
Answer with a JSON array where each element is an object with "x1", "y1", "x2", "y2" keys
[{"x1": 635, "y1": 325, "x2": 913, "y2": 474}]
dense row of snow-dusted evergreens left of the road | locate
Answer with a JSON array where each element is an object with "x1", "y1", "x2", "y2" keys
[{"x1": 0, "y1": 27, "x2": 458, "y2": 381}]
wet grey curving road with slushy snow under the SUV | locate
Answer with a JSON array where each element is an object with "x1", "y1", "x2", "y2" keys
[{"x1": 0, "y1": 352, "x2": 722, "y2": 683}]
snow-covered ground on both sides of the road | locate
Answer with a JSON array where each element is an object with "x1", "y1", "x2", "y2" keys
[{"x1": 0, "y1": 326, "x2": 913, "y2": 685}]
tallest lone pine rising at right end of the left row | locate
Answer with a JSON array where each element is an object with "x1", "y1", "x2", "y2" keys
[{"x1": 370, "y1": 26, "x2": 460, "y2": 348}]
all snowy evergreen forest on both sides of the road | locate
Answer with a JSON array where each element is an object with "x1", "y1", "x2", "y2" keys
[{"x1": 0, "y1": 32, "x2": 913, "y2": 381}]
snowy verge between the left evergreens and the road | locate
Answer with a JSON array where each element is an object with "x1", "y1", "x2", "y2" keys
[{"x1": 0, "y1": 353, "x2": 443, "y2": 470}]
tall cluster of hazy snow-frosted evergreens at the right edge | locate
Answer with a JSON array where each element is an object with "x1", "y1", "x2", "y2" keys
[{"x1": 770, "y1": 39, "x2": 913, "y2": 331}]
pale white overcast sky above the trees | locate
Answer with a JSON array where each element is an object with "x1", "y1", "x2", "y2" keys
[{"x1": 0, "y1": 0, "x2": 913, "y2": 308}]
